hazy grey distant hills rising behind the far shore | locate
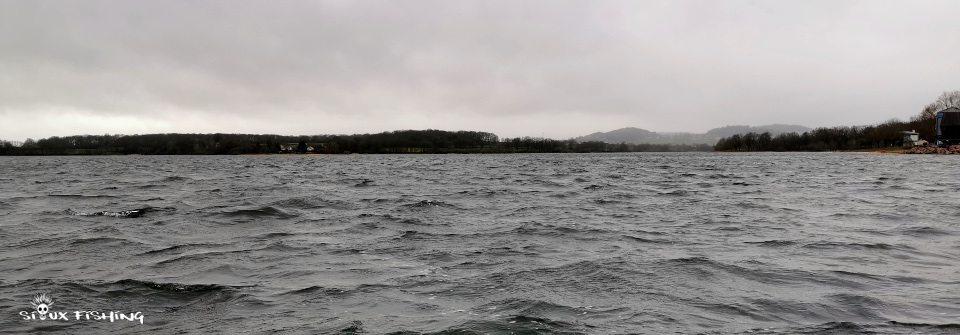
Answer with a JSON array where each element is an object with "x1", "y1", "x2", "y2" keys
[{"x1": 574, "y1": 124, "x2": 811, "y2": 144}]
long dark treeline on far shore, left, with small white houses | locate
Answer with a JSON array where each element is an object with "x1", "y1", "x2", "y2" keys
[{"x1": 0, "y1": 129, "x2": 713, "y2": 155}]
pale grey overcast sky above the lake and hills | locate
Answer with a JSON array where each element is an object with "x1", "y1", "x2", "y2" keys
[{"x1": 0, "y1": 0, "x2": 960, "y2": 141}]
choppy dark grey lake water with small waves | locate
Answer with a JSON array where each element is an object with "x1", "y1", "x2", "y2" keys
[{"x1": 0, "y1": 153, "x2": 960, "y2": 334}]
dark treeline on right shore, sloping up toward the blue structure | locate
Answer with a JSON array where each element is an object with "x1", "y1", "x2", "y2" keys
[{"x1": 714, "y1": 91, "x2": 960, "y2": 151}]
